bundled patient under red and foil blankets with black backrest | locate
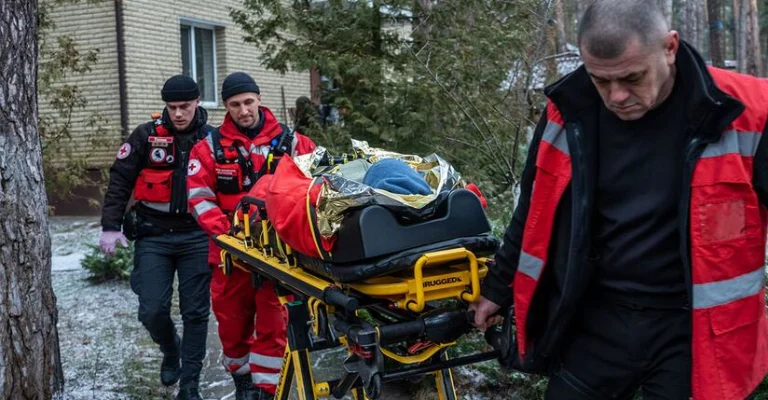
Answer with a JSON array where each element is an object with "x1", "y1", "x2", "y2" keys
[{"x1": 237, "y1": 142, "x2": 498, "y2": 282}]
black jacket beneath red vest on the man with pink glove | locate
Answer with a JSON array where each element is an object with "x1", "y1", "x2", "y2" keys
[{"x1": 101, "y1": 107, "x2": 213, "y2": 231}]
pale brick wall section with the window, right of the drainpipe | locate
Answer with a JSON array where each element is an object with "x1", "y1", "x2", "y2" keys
[{"x1": 123, "y1": 0, "x2": 310, "y2": 132}]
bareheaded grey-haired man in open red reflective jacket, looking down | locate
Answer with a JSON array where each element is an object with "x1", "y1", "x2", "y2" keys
[{"x1": 472, "y1": 0, "x2": 768, "y2": 400}]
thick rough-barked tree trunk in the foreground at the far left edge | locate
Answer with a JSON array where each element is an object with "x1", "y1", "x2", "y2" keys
[{"x1": 0, "y1": 0, "x2": 63, "y2": 400}]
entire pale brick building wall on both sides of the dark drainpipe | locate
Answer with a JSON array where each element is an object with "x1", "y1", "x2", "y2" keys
[{"x1": 40, "y1": 0, "x2": 310, "y2": 168}]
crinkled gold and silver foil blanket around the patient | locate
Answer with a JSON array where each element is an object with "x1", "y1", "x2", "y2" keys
[{"x1": 294, "y1": 140, "x2": 466, "y2": 238}]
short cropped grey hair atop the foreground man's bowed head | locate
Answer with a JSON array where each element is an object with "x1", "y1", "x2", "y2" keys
[{"x1": 578, "y1": 0, "x2": 669, "y2": 59}]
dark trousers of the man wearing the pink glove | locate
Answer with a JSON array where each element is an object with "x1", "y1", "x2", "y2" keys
[{"x1": 131, "y1": 230, "x2": 211, "y2": 388}]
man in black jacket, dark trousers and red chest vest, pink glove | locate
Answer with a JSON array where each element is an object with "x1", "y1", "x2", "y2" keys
[{"x1": 99, "y1": 75, "x2": 212, "y2": 399}]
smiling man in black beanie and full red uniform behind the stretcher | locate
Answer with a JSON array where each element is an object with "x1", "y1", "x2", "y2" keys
[{"x1": 187, "y1": 72, "x2": 315, "y2": 400}]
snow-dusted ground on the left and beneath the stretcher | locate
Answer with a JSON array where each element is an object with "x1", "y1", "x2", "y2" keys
[{"x1": 50, "y1": 217, "x2": 496, "y2": 400}]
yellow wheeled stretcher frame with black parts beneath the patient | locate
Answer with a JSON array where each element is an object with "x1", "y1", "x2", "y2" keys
[{"x1": 215, "y1": 188, "x2": 508, "y2": 400}]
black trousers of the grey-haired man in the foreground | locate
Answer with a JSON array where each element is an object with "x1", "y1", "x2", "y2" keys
[{"x1": 546, "y1": 299, "x2": 691, "y2": 400}]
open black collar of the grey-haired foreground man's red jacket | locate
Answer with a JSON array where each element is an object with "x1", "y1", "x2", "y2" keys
[{"x1": 544, "y1": 40, "x2": 744, "y2": 142}]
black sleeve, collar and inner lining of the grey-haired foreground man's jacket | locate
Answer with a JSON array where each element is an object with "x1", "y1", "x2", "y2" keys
[{"x1": 482, "y1": 42, "x2": 768, "y2": 373}]
